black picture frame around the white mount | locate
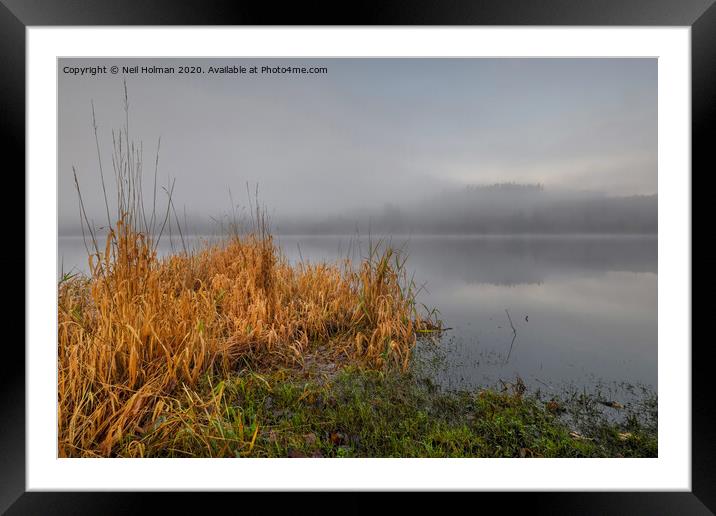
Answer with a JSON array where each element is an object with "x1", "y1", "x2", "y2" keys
[{"x1": 0, "y1": 0, "x2": 704, "y2": 514}]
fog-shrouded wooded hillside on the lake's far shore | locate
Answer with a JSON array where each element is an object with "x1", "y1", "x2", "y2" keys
[{"x1": 276, "y1": 183, "x2": 658, "y2": 234}]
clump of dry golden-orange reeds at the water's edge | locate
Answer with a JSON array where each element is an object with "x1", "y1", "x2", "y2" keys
[{"x1": 58, "y1": 216, "x2": 437, "y2": 456}]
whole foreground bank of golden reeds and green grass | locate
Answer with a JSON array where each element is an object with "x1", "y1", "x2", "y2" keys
[{"x1": 57, "y1": 88, "x2": 657, "y2": 457}]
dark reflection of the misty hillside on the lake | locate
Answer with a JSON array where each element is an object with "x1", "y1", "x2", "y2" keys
[{"x1": 279, "y1": 236, "x2": 658, "y2": 286}]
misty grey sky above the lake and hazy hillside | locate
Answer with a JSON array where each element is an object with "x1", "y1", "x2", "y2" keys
[{"x1": 58, "y1": 58, "x2": 657, "y2": 232}]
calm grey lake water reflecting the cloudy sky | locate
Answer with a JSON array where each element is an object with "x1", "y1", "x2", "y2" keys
[{"x1": 58, "y1": 236, "x2": 657, "y2": 391}]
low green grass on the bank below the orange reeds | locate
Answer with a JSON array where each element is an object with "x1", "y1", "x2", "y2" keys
[{"x1": 131, "y1": 369, "x2": 657, "y2": 457}]
